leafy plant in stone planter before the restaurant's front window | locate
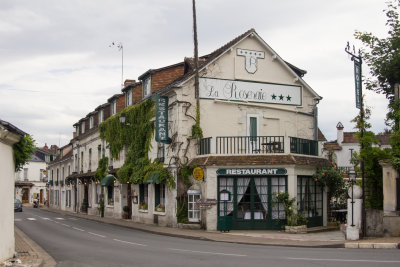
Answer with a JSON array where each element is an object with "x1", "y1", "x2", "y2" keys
[{"x1": 274, "y1": 191, "x2": 307, "y2": 234}]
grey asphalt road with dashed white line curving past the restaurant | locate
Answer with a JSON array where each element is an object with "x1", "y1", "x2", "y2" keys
[{"x1": 15, "y1": 207, "x2": 400, "y2": 267}]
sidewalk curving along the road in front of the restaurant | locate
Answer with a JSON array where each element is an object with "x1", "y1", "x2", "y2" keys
[{"x1": 36, "y1": 207, "x2": 400, "y2": 248}]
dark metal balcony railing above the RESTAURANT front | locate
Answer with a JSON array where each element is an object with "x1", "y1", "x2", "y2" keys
[{"x1": 198, "y1": 136, "x2": 318, "y2": 156}]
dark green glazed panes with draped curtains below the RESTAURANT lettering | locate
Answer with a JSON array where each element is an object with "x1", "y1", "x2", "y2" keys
[{"x1": 218, "y1": 176, "x2": 287, "y2": 230}]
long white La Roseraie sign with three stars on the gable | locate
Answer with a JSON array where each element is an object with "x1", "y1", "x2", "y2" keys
[{"x1": 199, "y1": 78, "x2": 301, "y2": 106}]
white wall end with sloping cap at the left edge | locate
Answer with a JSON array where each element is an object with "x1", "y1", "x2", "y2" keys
[{"x1": 0, "y1": 120, "x2": 26, "y2": 262}]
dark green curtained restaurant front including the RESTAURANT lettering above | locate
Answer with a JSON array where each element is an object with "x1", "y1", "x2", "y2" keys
[{"x1": 217, "y1": 168, "x2": 288, "y2": 230}]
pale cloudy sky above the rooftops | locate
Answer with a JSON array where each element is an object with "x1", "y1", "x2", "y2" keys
[{"x1": 0, "y1": 0, "x2": 388, "y2": 149}]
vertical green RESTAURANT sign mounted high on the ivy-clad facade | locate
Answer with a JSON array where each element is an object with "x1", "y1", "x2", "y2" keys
[{"x1": 154, "y1": 96, "x2": 171, "y2": 144}]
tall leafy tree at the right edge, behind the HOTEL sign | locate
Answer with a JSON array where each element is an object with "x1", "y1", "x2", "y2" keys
[{"x1": 355, "y1": 0, "x2": 400, "y2": 171}]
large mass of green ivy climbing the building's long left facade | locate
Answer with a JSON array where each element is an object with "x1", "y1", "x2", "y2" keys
[{"x1": 99, "y1": 100, "x2": 175, "y2": 188}]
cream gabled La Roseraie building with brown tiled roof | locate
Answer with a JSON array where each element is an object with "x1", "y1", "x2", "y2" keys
[{"x1": 50, "y1": 29, "x2": 329, "y2": 230}]
